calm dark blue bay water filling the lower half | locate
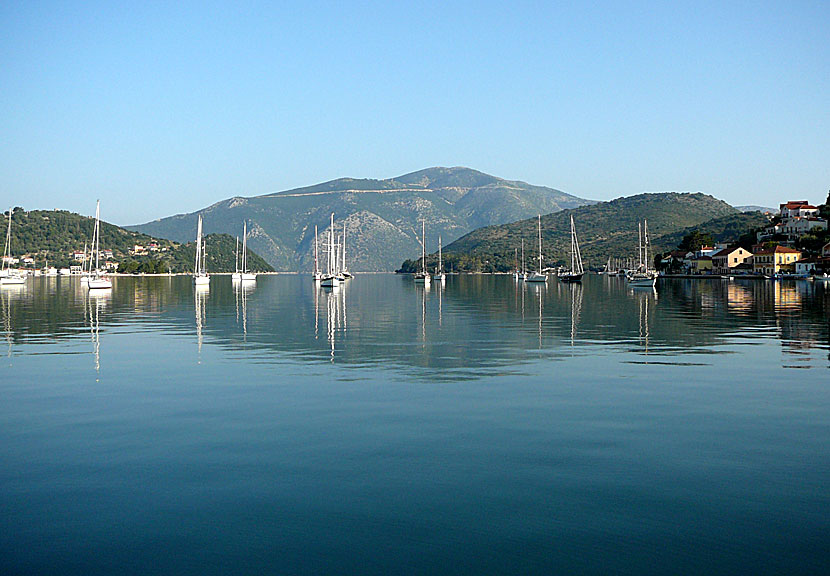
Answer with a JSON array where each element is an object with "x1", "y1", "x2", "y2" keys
[{"x1": 0, "y1": 275, "x2": 830, "y2": 574}]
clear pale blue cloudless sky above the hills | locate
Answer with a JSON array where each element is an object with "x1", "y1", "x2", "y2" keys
[{"x1": 0, "y1": 1, "x2": 830, "y2": 224}]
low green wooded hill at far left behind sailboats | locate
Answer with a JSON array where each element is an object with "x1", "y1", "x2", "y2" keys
[{"x1": 0, "y1": 208, "x2": 273, "y2": 272}]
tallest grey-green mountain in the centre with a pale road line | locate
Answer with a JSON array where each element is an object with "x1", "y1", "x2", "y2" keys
[{"x1": 129, "y1": 168, "x2": 592, "y2": 271}]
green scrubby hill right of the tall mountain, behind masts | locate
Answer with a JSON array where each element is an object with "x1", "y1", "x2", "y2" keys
[{"x1": 402, "y1": 192, "x2": 744, "y2": 271}]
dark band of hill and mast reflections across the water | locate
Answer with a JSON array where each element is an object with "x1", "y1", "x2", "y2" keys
[{"x1": 6, "y1": 275, "x2": 830, "y2": 378}]
